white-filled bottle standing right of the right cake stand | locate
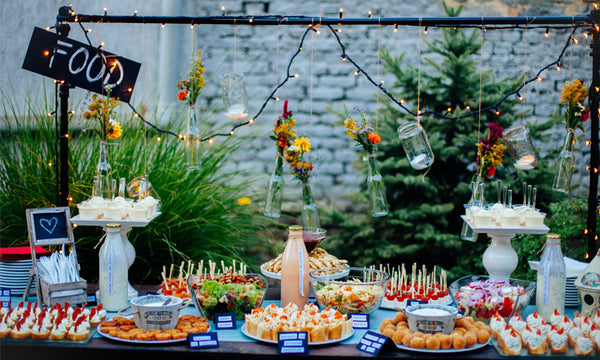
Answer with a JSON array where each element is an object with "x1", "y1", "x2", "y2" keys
[{"x1": 535, "y1": 234, "x2": 567, "y2": 319}]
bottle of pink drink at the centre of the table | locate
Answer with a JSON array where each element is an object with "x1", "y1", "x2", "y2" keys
[{"x1": 281, "y1": 225, "x2": 310, "y2": 308}]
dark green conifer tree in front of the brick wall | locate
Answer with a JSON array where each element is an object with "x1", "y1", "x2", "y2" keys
[{"x1": 324, "y1": 4, "x2": 554, "y2": 278}]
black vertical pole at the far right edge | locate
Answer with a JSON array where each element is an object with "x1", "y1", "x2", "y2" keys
[{"x1": 586, "y1": 10, "x2": 600, "y2": 258}]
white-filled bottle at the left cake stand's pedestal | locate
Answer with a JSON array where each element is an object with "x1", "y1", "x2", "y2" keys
[{"x1": 98, "y1": 224, "x2": 129, "y2": 311}]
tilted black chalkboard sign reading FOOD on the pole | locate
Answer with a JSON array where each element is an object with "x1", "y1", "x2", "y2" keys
[{"x1": 23, "y1": 27, "x2": 141, "y2": 102}]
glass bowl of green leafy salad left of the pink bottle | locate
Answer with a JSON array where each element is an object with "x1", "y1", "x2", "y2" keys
[{"x1": 187, "y1": 272, "x2": 268, "y2": 320}]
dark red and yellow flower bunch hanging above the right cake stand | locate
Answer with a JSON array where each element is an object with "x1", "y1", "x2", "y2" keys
[{"x1": 474, "y1": 122, "x2": 506, "y2": 178}]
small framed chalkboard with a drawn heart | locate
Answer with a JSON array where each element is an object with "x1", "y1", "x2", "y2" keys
[{"x1": 26, "y1": 207, "x2": 73, "y2": 245}]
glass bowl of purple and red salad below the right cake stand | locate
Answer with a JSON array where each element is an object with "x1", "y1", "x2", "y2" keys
[{"x1": 449, "y1": 275, "x2": 535, "y2": 322}]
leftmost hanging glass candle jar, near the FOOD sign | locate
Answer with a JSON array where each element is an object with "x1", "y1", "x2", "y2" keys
[{"x1": 221, "y1": 71, "x2": 248, "y2": 120}]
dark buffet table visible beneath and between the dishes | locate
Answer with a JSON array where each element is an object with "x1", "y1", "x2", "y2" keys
[{"x1": 0, "y1": 285, "x2": 580, "y2": 360}]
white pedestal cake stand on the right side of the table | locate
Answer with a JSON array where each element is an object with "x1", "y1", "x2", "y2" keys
[{"x1": 461, "y1": 215, "x2": 550, "y2": 282}]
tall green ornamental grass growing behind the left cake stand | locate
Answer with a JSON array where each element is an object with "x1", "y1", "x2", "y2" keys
[{"x1": 0, "y1": 89, "x2": 271, "y2": 283}]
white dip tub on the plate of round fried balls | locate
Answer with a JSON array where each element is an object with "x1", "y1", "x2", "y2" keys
[{"x1": 404, "y1": 304, "x2": 458, "y2": 334}]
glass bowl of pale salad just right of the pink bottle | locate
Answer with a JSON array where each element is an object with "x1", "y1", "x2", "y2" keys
[{"x1": 309, "y1": 267, "x2": 390, "y2": 314}]
